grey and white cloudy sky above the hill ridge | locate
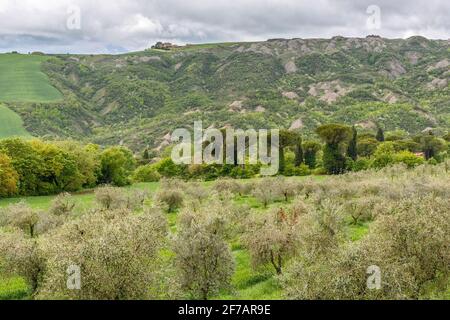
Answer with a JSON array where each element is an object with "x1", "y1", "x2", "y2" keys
[{"x1": 0, "y1": 0, "x2": 450, "y2": 53}]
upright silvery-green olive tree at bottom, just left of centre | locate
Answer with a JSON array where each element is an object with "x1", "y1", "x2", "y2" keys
[{"x1": 173, "y1": 209, "x2": 234, "y2": 300}]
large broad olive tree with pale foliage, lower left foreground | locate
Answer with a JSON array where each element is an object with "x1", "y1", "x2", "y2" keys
[{"x1": 37, "y1": 209, "x2": 167, "y2": 300}]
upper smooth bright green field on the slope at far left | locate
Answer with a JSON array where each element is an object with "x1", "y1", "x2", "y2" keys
[{"x1": 0, "y1": 54, "x2": 62, "y2": 102}]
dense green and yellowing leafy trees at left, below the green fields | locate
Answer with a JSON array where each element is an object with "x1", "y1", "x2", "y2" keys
[{"x1": 0, "y1": 138, "x2": 135, "y2": 197}]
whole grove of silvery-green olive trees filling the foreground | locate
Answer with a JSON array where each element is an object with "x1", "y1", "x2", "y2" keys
[{"x1": 0, "y1": 163, "x2": 450, "y2": 299}]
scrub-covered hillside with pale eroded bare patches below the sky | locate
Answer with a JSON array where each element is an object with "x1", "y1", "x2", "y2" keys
[{"x1": 0, "y1": 36, "x2": 450, "y2": 150}]
